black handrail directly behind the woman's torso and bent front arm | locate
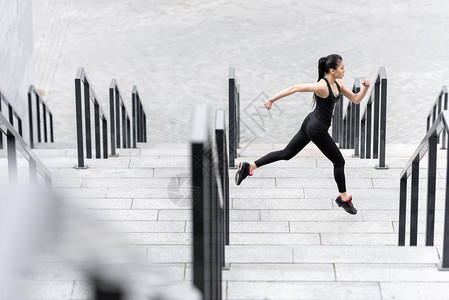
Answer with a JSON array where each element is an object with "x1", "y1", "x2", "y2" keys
[{"x1": 332, "y1": 78, "x2": 360, "y2": 156}]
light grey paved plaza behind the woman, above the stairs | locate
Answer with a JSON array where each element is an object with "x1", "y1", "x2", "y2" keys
[{"x1": 33, "y1": 0, "x2": 449, "y2": 145}]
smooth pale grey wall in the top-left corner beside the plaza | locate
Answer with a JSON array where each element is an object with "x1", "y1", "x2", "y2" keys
[{"x1": 0, "y1": 0, "x2": 34, "y2": 133}]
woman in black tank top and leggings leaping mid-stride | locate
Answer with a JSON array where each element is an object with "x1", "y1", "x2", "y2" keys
[{"x1": 235, "y1": 54, "x2": 370, "y2": 214}]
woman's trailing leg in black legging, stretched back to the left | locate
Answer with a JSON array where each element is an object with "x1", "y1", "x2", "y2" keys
[{"x1": 250, "y1": 117, "x2": 310, "y2": 171}]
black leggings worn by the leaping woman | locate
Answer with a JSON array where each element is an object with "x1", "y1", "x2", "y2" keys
[{"x1": 254, "y1": 112, "x2": 346, "y2": 193}]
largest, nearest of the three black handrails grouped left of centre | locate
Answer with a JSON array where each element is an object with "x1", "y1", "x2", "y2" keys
[{"x1": 75, "y1": 68, "x2": 108, "y2": 168}]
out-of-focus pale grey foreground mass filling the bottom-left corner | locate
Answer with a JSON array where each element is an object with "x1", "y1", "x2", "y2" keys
[{"x1": 0, "y1": 186, "x2": 201, "y2": 300}]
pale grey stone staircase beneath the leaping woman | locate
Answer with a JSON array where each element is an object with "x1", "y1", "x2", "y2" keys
[{"x1": 7, "y1": 143, "x2": 449, "y2": 300}]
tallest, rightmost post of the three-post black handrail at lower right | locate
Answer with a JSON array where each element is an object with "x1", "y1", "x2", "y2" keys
[{"x1": 426, "y1": 135, "x2": 438, "y2": 246}]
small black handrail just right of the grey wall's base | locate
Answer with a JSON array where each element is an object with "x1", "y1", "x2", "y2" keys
[{"x1": 28, "y1": 85, "x2": 54, "y2": 148}]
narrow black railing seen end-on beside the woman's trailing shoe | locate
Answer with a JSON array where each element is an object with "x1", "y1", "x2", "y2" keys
[{"x1": 229, "y1": 68, "x2": 240, "y2": 168}]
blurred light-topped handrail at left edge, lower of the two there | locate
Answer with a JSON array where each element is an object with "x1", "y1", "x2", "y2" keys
[{"x1": 0, "y1": 109, "x2": 52, "y2": 188}]
